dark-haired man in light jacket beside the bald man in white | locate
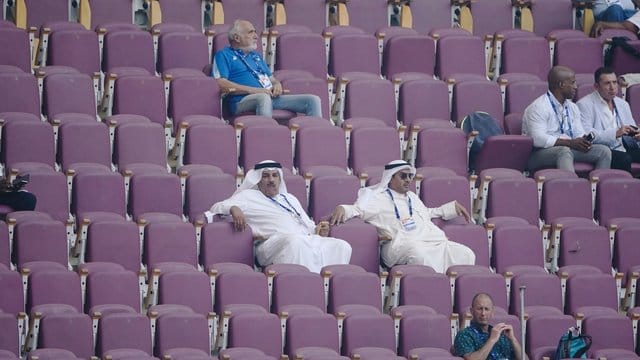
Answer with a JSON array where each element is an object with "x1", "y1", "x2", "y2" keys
[{"x1": 577, "y1": 67, "x2": 640, "y2": 171}]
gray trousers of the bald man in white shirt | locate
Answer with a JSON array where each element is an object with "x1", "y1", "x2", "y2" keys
[{"x1": 529, "y1": 144, "x2": 611, "y2": 172}]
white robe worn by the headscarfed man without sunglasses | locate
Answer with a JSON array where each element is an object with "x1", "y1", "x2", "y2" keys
[{"x1": 210, "y1": 189, "x2": 351, "y2": 273}]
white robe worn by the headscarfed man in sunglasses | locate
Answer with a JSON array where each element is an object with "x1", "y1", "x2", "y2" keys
[{"x1": 341, "y1": 190, "x2": 475, "y2": 273}]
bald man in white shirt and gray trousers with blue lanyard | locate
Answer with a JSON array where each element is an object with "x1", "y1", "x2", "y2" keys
[{"x1": 522, "y1": 66, "x2": 611, "y2": 171}]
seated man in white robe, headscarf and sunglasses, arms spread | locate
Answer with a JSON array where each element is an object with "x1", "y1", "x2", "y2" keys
[{"x1": 330, "y1": 160, "x2": 475, "y2": 273}]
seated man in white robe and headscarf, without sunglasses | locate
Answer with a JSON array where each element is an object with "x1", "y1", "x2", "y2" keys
[{"x1": 205, "y1": 160, "x2": 351, "y2": 272}]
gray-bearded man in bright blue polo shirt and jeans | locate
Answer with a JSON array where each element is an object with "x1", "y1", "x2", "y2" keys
[{"x1": 211, "y1": 20, "x2": 322, "y2": 117}]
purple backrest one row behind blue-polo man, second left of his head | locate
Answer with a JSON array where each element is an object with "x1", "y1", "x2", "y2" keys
[{"x1": 104, "y1": 29, "x2": 155, "y2": 74}]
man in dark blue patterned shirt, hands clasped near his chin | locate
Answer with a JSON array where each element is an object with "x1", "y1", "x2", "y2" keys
[{"x1": 453, "y1": 293, "x2": 523, "y2": 360}]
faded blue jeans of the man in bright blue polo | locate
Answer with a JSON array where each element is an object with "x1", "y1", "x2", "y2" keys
[{"x1": 236, "y1": 94, "x2": 322, "y2": 117}]
